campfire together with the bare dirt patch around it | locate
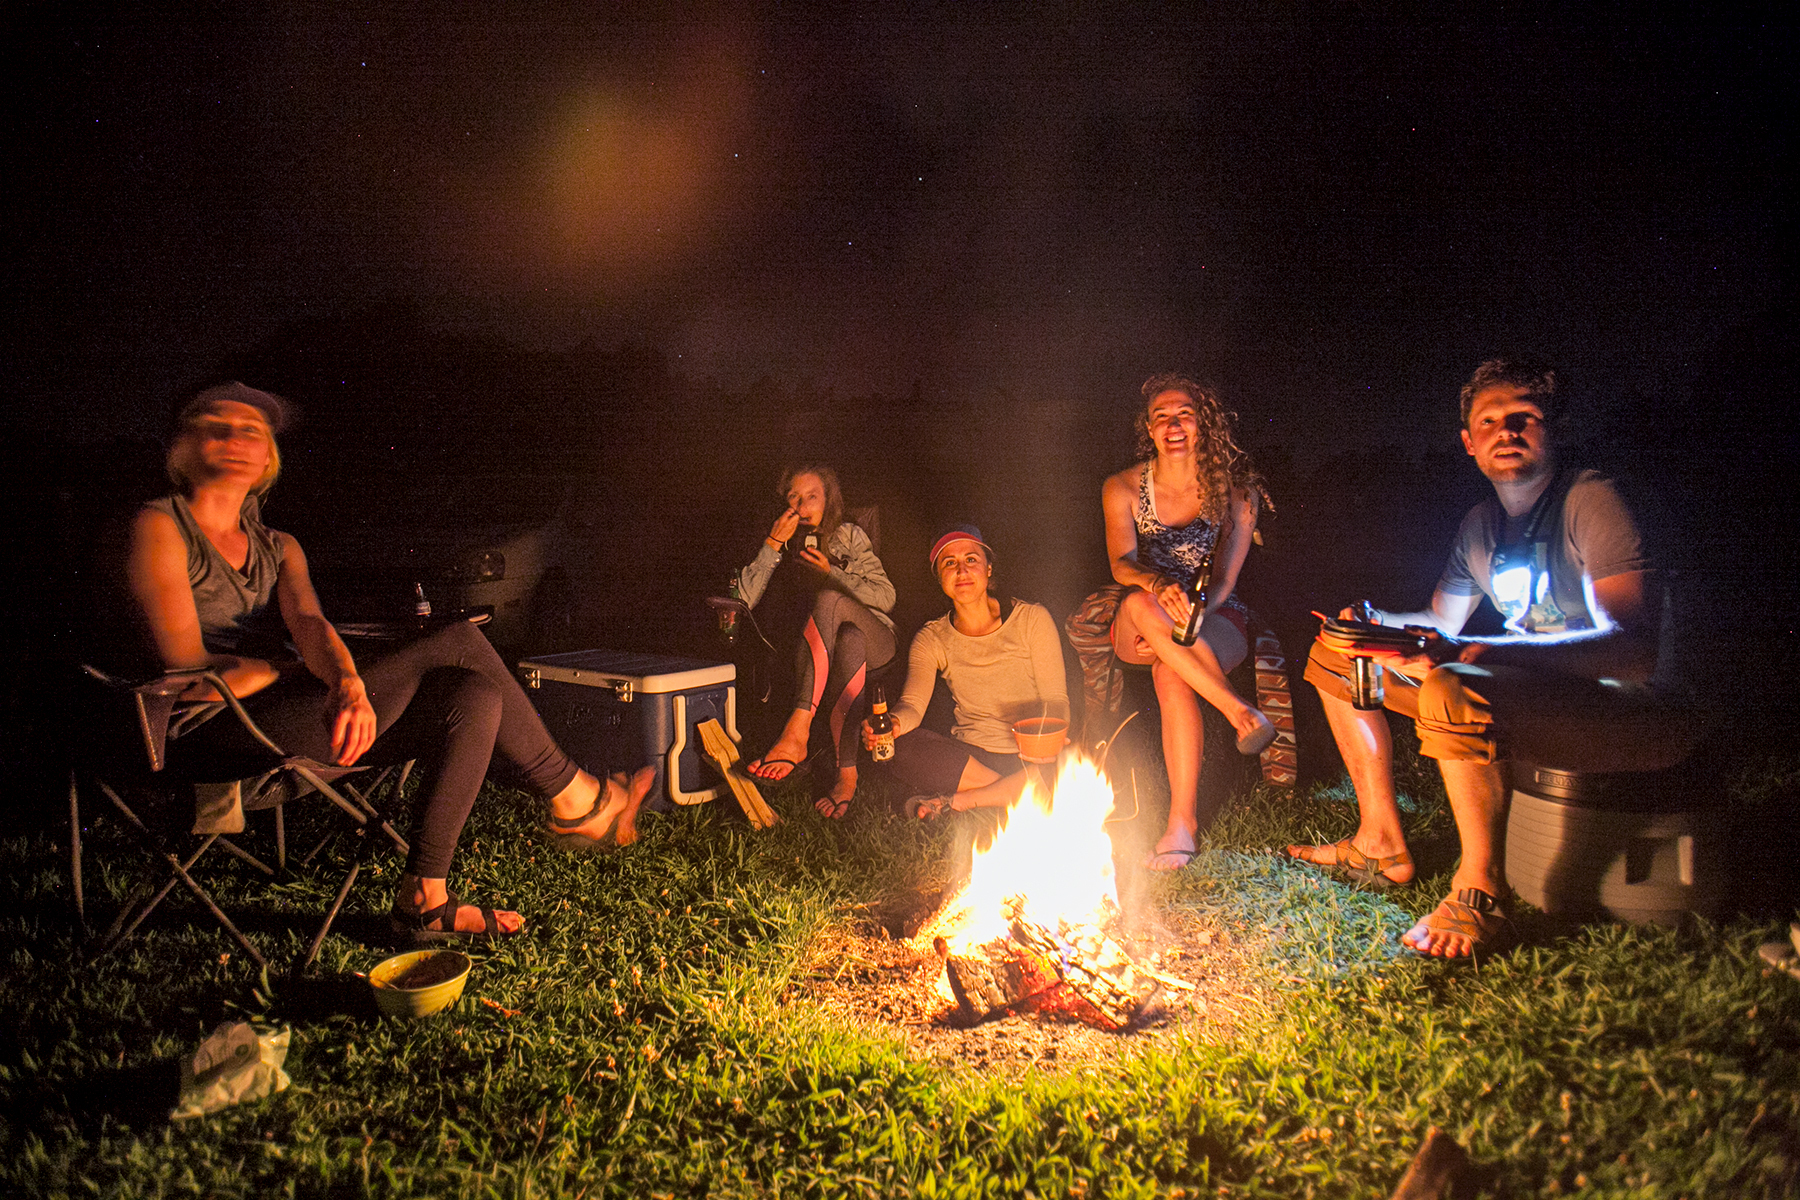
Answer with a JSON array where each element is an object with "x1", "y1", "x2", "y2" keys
[{"x1": 790, "y1": 756, "x2": 1258, "y2": 1063}]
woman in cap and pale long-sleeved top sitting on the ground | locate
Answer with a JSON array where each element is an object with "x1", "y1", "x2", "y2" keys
[{"x1": 862, "y1": 525, "x2": 1069, "y2": 819}]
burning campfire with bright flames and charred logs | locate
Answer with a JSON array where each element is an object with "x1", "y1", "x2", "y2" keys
[{"x1": 920, "y1": 756, "x2": 1192, "y2": 1029}]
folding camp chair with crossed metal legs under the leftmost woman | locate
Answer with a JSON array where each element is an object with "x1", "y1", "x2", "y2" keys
[{"x1": 68, "y1": 666, "x2": 412, "y2": 975}]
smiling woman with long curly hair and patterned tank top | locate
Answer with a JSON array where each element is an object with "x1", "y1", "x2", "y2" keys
[{"x1": 1100, "y1": 374, "x2": 1274, "y2": 871}]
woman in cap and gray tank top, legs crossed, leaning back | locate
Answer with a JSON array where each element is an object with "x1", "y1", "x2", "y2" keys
[{"x1": 126, "y1": 383, "x2": 655, "y2": 943}]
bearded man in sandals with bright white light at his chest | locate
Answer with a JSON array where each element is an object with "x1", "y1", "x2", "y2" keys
[{"x1": 1287, "y1": 358, "x2": 1696, "y2": 957}]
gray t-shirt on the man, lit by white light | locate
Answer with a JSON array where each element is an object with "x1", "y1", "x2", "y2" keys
[{"x1": 1438, "y1": 471, "x2": 1651, "y2": 633}]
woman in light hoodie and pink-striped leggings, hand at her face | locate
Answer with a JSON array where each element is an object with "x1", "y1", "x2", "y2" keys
[{"x1": 738, "y1": 466, "x2": 895, "y2": 820}]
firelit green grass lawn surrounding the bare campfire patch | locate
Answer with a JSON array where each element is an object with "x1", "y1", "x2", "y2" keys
[{"x1": 0, "y1": 744, "x2": 1800, "y2": 1198}]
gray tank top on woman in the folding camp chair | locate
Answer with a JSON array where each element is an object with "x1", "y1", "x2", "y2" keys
[{"x1": 149, "y1": 497, "x2": 292, "y2": 658}]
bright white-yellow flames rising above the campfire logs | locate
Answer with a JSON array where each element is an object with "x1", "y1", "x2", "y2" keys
[{"x1": 922, "y1": 756, "x2": 1118, "y2": 952}]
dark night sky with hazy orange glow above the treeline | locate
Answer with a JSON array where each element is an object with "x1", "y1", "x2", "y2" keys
[{"x1": 0, "y1": 2, "x2": 1793, "y2": 450}]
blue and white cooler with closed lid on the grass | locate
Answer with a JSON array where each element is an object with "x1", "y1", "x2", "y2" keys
[{"x1": 518, "y1": 649, "x2": 740, "y2": 810}]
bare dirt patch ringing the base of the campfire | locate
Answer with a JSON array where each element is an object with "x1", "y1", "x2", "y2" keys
[{"x1": 788, "y1": 899, "x2": 1262, "y2": 1070}]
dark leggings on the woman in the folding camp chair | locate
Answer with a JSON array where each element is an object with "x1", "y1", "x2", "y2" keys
[{"x1": 182, "y1": 621, "x2": 578, "y2": 880}]
